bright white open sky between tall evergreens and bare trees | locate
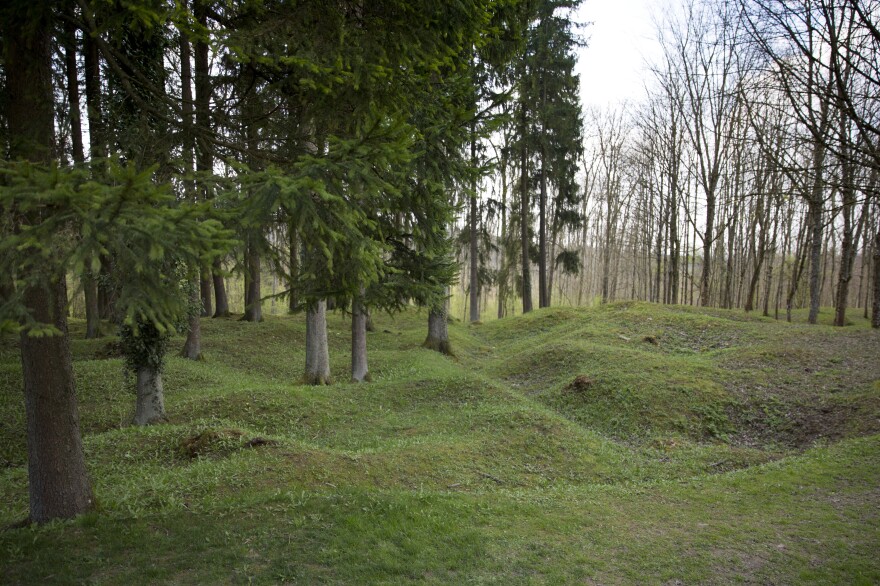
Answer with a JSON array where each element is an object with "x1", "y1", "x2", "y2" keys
[{"x1": 575, "y1": 0, "x2": 669, "y2": 111}]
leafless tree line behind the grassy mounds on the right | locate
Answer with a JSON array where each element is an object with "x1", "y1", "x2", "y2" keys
[{"x1": 462, "y1": 0, "x2": 880, "y2": 327}]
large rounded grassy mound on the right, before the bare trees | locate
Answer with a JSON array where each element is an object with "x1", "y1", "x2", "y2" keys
[{"x1": 467, "y1": 302, "x2": 880, "y2": 452}]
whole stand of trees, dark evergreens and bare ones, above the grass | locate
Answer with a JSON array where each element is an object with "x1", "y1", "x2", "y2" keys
[{"x1": 0, "y1": 0, "x2": 880, "y2": 520}]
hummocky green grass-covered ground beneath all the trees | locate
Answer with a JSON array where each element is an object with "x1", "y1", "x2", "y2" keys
[{"x1": 0, "y1": 303, "x2": 880, "y2": 584}]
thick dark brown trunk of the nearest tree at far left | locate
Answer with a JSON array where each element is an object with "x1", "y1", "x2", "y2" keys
[{"x1": 6, "y1": 2, "x2": 92, "y2": 523}]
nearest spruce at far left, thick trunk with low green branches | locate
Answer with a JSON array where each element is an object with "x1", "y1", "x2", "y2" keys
[{"x1": 0, "y1": 2, "x2": 234, "y2": 522}]
